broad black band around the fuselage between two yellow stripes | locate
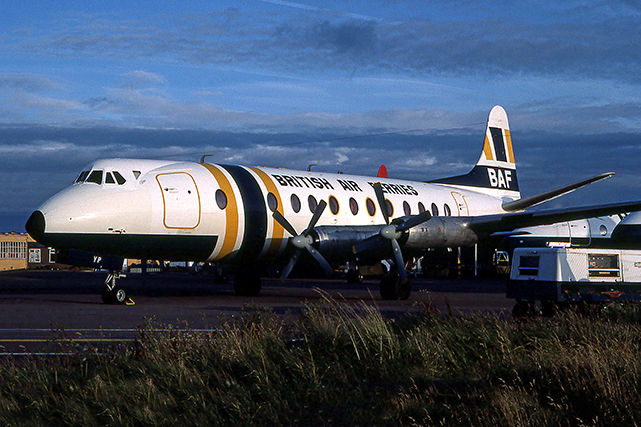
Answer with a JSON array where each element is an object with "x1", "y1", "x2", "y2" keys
[{"x1": 220, "y1": 165, "x2": 267, "y2": 262}]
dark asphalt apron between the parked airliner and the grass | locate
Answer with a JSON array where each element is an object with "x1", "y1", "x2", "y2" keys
[{"x1": 0, "y1": 270, "x2": 514, "y2": 355}]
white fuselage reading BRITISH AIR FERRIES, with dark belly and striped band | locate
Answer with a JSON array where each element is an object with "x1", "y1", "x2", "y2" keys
[{"x1": 31, "y1": 159, "x2": 510, "y2": 261}]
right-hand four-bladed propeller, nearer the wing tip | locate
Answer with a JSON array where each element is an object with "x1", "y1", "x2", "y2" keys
[{"x1": 353, "y1": 182, "x2": 432, "y2": 283}]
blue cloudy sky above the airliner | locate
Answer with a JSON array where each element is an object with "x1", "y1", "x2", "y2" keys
[{"x1": 0, "y1": 0, "x2": 641, "y2": 232}]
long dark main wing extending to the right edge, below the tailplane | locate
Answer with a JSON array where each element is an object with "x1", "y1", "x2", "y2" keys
[{"x1": 467, "y1": 201, "x2": 641, "y2": 234}]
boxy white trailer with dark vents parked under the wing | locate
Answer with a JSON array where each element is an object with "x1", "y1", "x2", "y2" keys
[{"x1": 507, "y1": 247, "x2": 641, "y2": 317}]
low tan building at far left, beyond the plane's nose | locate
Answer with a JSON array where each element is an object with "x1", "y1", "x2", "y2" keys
[{"x1": 0, "y1": 233, "x2": 56, "y2": 271}]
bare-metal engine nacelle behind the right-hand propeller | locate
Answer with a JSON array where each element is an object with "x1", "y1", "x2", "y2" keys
[{"x1": 403, "y1": 217, "x2": 478, "y2": 252}]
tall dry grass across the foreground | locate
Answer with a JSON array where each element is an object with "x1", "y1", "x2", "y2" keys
[{"x1": 0, "y1": 297, "x2": 641, "y2": 426}]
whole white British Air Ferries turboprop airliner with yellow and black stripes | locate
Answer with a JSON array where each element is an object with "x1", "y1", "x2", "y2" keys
[{"x1": 26, "y1": 106, "x2": 641, "y2": 303}]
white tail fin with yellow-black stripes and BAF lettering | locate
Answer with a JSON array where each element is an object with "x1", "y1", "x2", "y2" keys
[{"x1": 430, "y1": 105, "x2": 521, "y2": 200}]
